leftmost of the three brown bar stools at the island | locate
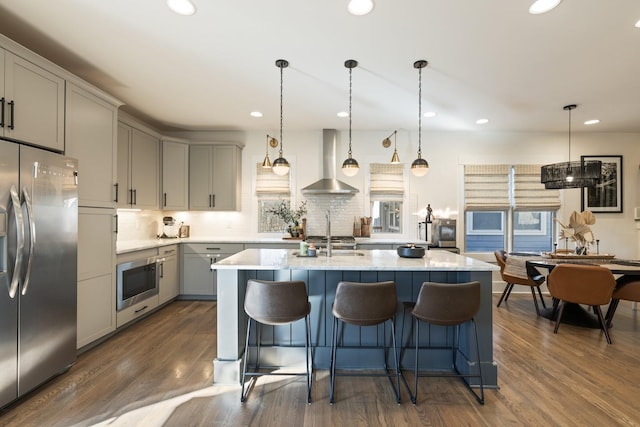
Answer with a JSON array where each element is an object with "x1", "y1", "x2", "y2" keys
[{"x1": 240, "y1": 280, "x2": 313, "y2": 403}]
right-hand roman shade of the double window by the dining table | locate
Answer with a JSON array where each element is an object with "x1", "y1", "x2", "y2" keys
[{"x1": 513, "y1": 165, "x2": 560, "y2": 211}]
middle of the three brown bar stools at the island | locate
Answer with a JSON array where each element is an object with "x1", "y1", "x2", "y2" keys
[{"x1": 329, "y1": 281, "x2": 400, "y2": 404}]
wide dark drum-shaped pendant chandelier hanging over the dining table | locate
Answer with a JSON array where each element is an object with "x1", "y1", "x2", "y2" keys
[{"x1": 540, "y1": 104, "x2": 602, "y2": 190}]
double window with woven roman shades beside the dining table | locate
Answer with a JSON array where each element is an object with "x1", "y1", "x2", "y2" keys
[{"x1": 465, "y1": 165, "x2": 560, "y2": 252}]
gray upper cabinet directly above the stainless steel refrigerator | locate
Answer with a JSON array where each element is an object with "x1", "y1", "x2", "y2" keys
[{"x1": 0, "y1": 49, "x2": 65, "y2": 152}]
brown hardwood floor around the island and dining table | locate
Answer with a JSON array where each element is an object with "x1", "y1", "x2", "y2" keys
[{"x1": 0, "y1": 294, "x2": 640, "y2": 427}]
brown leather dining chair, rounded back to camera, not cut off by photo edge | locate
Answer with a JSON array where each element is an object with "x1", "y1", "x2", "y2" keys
[{"x1": 547, "y1": 264, "x2": 616, "y2": 344}]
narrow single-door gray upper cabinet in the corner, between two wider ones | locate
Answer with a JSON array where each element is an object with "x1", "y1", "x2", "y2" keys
[{"x1": 160, "y1": 139, "x2": 189, "y2": 211}]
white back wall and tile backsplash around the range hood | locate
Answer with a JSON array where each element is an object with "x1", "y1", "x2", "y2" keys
[{"x1": 138, "y1": 129, "x2": 640, "y2": 258}]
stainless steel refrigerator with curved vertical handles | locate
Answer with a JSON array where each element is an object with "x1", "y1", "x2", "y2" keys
[{"x1": 0, "y1": 141, "x2": 78, "y2": 408}]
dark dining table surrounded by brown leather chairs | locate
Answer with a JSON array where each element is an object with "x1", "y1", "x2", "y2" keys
[{"x1": 526, "y1": 256, "x2": 640, "y2": 329}]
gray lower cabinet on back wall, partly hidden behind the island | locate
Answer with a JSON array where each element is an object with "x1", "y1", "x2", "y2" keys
[{"x1": 180, "y1": 243, "x2": 244, "y2": 300}]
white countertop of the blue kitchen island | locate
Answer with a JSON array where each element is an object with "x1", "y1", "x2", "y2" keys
[{"x1": 216, "y1": 249, "x2": 499, "y2": 271}]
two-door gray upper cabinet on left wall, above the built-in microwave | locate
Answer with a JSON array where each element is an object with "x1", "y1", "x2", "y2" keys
[{"x1": 117, "y1": 122, "x2": 160, "y2": 209}]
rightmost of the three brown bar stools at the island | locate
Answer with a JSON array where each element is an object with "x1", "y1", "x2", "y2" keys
[{"x1": 403, "y1": 282, "x2": 484, "y2": 405}]
